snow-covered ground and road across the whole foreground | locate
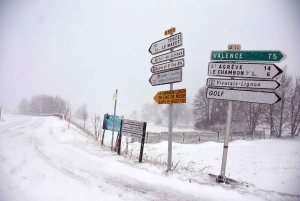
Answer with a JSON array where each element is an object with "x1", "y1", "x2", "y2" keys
[{"x1": 0, "y1": 114, "x2": 300, "y2": 201}]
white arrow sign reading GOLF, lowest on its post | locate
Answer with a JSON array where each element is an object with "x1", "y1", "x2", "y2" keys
[{"x1": 206, "y1": 88, "x2": 281, "y2": 104}]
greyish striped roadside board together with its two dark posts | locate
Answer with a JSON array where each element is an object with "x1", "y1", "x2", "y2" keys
[{"x1": 118, "y1": 119, "x2": 147, "y2": 163}]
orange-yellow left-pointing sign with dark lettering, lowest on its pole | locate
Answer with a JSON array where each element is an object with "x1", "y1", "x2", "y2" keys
[{"x1": 153, "y1": 89, "x2": 186, "y2": 104}]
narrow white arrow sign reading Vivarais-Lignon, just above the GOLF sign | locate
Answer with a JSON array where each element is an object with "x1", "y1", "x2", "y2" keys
[{"x1": 206, "y1": 78, "x2": 280, "y2": 89}]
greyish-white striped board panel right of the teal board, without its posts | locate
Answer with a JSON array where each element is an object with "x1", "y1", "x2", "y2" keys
[{"x1": 121, "y1": 119, "x2": 144, "y2": 138}]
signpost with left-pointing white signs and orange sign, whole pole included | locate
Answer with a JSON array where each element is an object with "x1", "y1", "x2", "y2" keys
[{"x1": 149, "y1": 28, "x2": 186, "y2": 172}]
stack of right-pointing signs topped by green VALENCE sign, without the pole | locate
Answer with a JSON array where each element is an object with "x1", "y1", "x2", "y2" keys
[{"x1": 206, "y1": 45, "x2": 286, "y2": 104}]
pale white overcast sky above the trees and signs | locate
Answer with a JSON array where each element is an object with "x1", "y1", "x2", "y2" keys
[{"x1": 0, "y1": 0, "x2": 300, "y2": 117}]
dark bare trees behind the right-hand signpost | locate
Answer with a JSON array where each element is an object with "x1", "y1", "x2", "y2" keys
[{"x1": 193, "y1": 67, "x2": 300, "y2": 138}]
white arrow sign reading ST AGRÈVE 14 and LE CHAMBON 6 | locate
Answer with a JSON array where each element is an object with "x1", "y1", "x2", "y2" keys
[{"x1": 208, "y1": 62, "x2": 282, "y2": 79}]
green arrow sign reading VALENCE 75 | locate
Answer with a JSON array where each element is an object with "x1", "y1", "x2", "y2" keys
[{"x1": 210, "y1": 50, "x2": 286, "y2": 62}]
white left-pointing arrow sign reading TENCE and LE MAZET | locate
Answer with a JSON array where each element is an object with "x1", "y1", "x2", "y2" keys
[{"x1": 149, "y1": 33, "x2": 182, "y2": 54}]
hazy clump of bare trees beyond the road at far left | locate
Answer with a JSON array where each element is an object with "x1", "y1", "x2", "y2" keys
[{"x1": 19, "y1": 95, "x2": 70, "y2": 116}]
